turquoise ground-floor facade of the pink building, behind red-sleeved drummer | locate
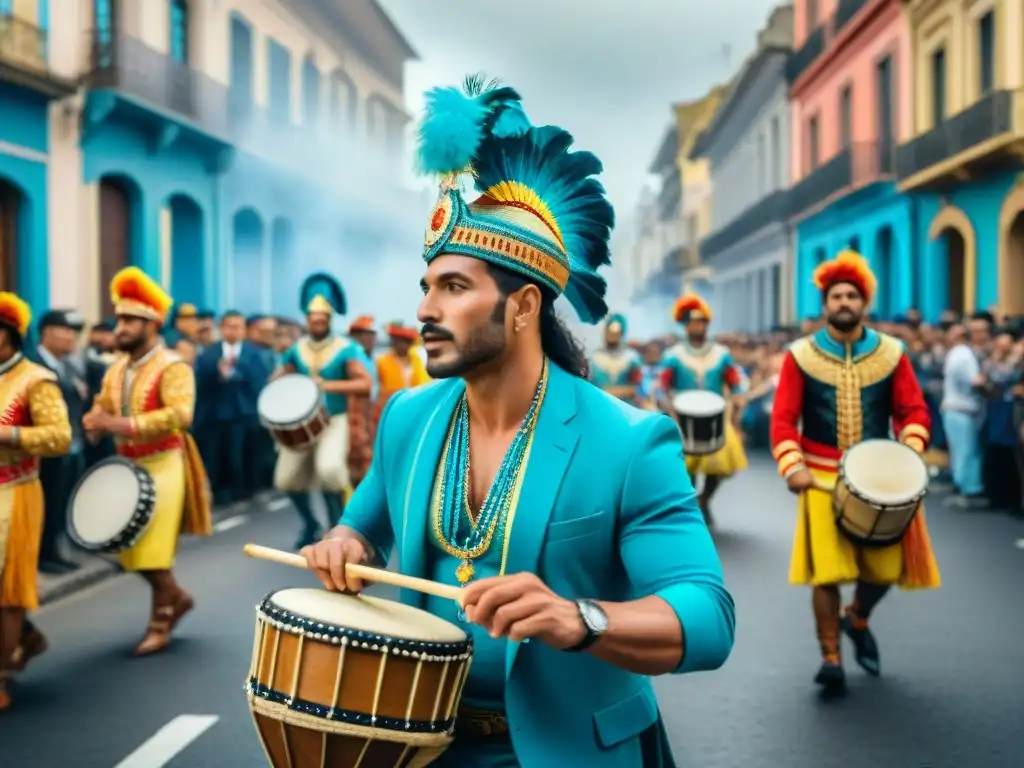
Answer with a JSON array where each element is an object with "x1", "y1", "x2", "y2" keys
[{"x1": 795, "y1": 182, "x2": 928, "y2": 319}]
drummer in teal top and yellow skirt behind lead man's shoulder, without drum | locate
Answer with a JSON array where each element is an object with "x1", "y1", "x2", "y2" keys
[{"x1": 662, "y1": 294, "x2": 746, "y2": 525}]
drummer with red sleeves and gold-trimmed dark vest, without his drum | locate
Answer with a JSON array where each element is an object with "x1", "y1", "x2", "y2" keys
[{"x1": 771, "y1": 251, "x2": 939, "y2": 692}]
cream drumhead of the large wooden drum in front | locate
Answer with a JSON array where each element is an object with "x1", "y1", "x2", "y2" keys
[{"x1": 270, "y1": 589, "x2": 466, "y2": 643}]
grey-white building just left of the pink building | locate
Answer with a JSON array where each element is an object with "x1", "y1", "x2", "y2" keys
[{"x1": 690, "y1": 5, "x2": 793, "y2": 332}]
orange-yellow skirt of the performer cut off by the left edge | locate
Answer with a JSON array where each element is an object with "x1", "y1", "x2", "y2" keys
[{"x1": 0, "y1": 479, "x2": 43, "y2": 610}]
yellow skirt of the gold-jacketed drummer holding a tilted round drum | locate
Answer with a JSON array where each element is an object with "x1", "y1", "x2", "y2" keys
[{"x1": 118, "y1": 451, "x2": 185, "y2": 571}]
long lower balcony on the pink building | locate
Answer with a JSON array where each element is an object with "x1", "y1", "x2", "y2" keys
[{"x1": 788, "y1": 141, "x2": 895, "y2": 219}]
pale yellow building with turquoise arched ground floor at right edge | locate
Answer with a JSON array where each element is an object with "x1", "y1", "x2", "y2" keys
[{"x1": 896, "y1": 0, "x2": 1024, "y2": 319}]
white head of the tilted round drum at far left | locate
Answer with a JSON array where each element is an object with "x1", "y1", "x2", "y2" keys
[{"x1": 71, "y1": 464, "x2": 141, "y2": 544}]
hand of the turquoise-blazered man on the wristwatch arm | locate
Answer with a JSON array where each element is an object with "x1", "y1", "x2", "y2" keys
[{"x1": 464, "y1": 573, "x2": 587, "y2": 650}]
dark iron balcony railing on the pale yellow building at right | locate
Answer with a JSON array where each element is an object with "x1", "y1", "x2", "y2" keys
[{"x1": 896, "y1": 90, "x2": 1019, "y2": 180}]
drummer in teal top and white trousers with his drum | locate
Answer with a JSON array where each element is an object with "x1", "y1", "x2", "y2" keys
[{"x1": 266, "y1": 272, "x2": 373, "y2": 548}]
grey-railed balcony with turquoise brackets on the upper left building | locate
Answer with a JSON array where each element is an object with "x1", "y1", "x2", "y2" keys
[{"x1": 86, "y1": 35, "x2": 230, "y2": 145}]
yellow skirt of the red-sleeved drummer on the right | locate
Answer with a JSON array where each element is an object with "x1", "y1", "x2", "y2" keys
[{"x1": 790, "y1": 470, "x2": 941, "y2": 590}]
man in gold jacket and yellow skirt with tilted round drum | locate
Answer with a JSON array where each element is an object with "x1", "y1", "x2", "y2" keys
[{"x1": 81, "y1": 267, "x2": 213, "y2": 655}]
